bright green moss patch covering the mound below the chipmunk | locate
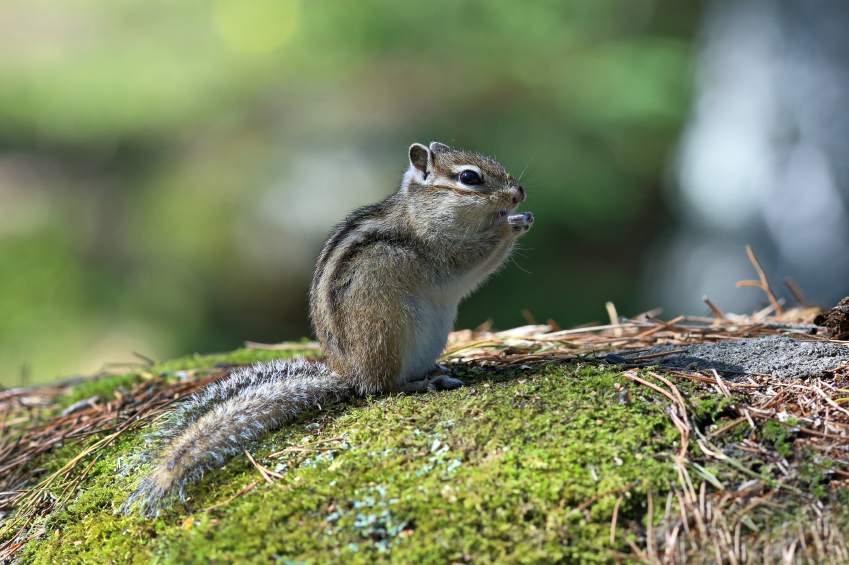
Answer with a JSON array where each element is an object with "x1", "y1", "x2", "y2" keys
[{"x1": 21, "y1": 365, "x2": 678, "y2": 564}]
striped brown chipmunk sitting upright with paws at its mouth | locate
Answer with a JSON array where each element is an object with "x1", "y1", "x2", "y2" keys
[{"x1": 124, "y1": 143, "x2": 534, "y2": 515}]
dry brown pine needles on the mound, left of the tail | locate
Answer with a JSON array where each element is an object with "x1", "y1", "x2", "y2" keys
[{"x1": 0, "y1": 369, "x2": 232, "y2": 562}]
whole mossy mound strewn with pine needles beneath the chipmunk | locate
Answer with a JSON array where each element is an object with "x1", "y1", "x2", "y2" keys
[{"x1": 0, "y1": 248, "x2": 849, "y2": 564}]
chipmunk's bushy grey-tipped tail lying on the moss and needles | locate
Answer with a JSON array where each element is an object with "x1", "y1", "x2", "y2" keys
[{"x1": 123, "y1": 359, "x2": 351, "y2": 515}]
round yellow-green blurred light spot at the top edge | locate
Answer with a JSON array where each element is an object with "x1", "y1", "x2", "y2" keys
[{"x1": 212, "y1": 0, "x2": 300, "y2": 53}]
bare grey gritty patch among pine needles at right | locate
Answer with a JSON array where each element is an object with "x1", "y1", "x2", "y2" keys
[{"x1": 624, "y1": 336, "x2": 849, "y2": 381}]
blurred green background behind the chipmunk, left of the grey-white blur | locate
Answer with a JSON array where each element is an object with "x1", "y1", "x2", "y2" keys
[{"x1": 0, "y1": 0, "x2": 701, "y2": 387}]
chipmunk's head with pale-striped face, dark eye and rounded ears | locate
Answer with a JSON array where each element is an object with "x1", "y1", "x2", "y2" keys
[{"x1": 401, "y1": 142, "x2": 526, "y2": 236}]
